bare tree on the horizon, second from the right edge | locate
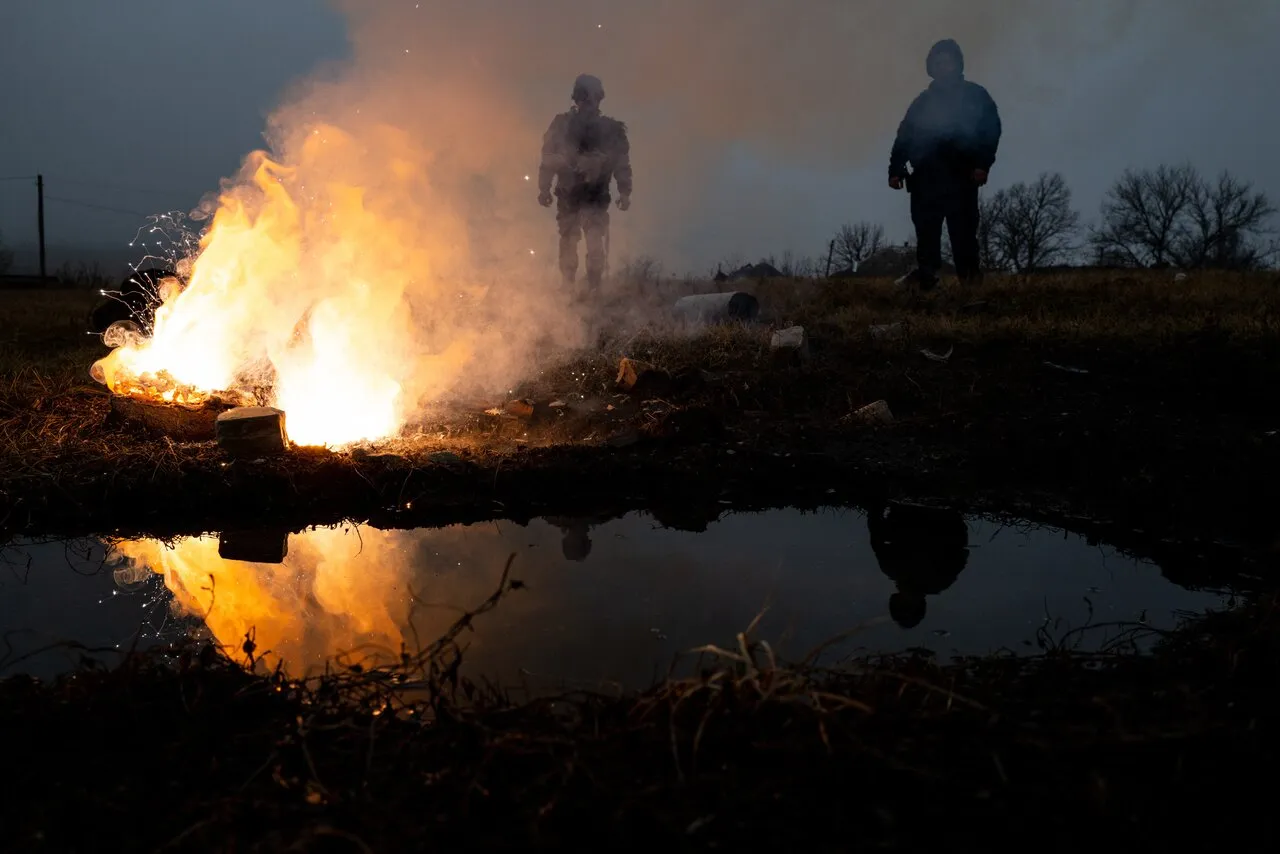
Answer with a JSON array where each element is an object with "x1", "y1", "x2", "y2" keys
[{"x1": 1089, "y1": 164, "x2": 1199, "y2": 266}]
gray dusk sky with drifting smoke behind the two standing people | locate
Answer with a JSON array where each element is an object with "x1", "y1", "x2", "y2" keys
[{"x1": 0, "y1": 0, "x2": 1280, "y2": 268}]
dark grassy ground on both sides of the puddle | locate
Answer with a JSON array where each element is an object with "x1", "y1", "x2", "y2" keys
[{"x1": 0, "y1": 273, "x2": 1280, "y2": 851}]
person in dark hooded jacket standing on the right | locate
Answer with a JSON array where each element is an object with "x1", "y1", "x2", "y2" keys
[{"x1": 888, "y1": 38, "x2": 1001, "y2": 291}]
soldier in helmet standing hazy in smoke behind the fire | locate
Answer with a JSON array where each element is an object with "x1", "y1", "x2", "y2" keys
[{"x1": 538, "y1": 74, "x2": 631, "y2": 300}]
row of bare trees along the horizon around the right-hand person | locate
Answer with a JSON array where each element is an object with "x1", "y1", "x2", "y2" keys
[{"x1": 831, "y1": 164, "x2": 1280, "y2": 273}]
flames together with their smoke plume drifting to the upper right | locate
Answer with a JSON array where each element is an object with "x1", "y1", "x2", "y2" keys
[{"x1": 104, "y1": 0, "x2": 1268, "y2": 442}]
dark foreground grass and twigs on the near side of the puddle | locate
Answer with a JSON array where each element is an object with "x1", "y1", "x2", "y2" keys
[{"x1": 0, "y1": 563, "x2": 1280, "y2": 851}]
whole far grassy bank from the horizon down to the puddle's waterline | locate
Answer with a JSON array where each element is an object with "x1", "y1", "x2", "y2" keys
[{"x1": 0, "y1": 273, "x2": 1280, "y2": 539}]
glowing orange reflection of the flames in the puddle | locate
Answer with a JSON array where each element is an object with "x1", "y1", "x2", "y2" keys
[{"x1": 116, "y1": 529, "x2": 413, "y2": 676}]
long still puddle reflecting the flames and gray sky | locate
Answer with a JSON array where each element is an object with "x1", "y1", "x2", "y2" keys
[{"x1": 0, "y1": 508, "x2": 1230, "y2": 690}]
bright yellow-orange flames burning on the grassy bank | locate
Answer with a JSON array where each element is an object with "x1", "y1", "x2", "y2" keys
[{"x1": 92, "y1": 124, "x2": 481, "y2": 446}]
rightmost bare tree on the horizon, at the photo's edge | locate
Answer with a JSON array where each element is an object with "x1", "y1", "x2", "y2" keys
[{"x1": 1172, "y1": 172, "x2": 1276, "y2": 270}]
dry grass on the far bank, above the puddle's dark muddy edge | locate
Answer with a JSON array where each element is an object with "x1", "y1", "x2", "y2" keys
[{"x1": 0, "y1": 273, "x2": 1280, "y2": 540}]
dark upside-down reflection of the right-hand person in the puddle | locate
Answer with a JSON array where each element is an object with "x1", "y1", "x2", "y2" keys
[{"x1": 867, "y1": 503, "x2": 969, "y2": 629}]
